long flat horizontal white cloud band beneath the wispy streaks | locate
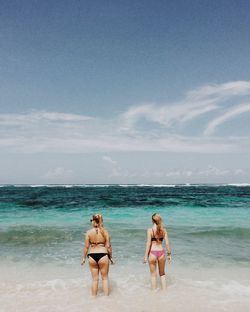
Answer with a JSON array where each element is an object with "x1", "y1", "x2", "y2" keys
[{"x1": 0, "y1": 133, "x2": 239, "y2": 154}]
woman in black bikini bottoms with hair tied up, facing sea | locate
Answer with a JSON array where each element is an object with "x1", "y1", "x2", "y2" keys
[{"x1": 81, "y1": 214, "x2": 113, "y2": 296}]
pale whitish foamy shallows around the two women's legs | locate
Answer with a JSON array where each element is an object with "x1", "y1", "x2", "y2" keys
[{"x1": 0, "y1": 264, "x2": 250, "y2": 312}]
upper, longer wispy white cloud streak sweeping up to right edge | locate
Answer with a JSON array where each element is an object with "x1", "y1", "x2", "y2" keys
[{"x1": 122, "y1": 81, "x2": 250, "y2": 130}]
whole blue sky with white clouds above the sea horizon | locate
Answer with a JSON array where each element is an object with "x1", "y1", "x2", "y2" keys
[{"x1": 0, "y1": 0, "x2": 250, "y2": 184}]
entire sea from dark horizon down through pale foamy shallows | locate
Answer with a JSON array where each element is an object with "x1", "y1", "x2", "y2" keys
[{"x1": 0, "y1": 184, "x2": 250, "y2": 312}]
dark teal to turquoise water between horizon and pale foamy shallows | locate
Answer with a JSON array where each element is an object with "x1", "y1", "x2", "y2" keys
[{"x1": 0, "y1": 185, "x2": 250, "y2": 266}]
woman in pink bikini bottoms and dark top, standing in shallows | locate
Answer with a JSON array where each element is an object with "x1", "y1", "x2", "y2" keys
[{"x1": 144, "y1": 213, "x2": 171, "y2": 290}]
